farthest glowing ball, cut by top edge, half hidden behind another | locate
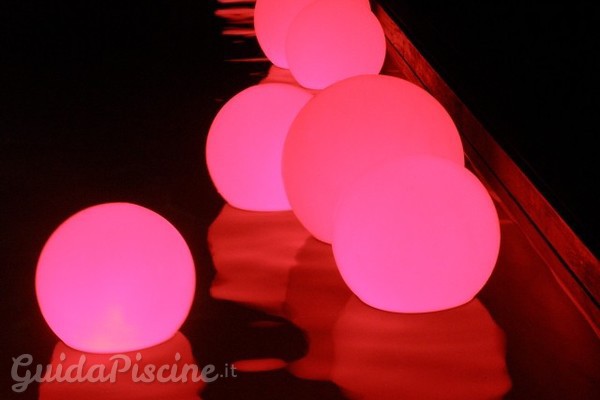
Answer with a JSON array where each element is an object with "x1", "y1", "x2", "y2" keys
[{"x1": 254, "y1": 0, "x2": 315, "y2": 68}]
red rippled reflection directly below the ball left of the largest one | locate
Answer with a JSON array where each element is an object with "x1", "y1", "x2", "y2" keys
[{"x1": 208, "y1": 205, "x2": 310, "y2": 316}]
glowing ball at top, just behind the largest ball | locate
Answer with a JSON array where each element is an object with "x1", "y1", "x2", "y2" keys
[{"x1": 285, "y1": 0, "x2": 386, "y2": 89}]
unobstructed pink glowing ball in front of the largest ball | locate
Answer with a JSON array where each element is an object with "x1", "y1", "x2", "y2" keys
[{"x1": 333, "y1": 156, "x2": 500, "y2": 312}]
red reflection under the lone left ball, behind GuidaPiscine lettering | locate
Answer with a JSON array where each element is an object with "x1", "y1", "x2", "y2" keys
[{"x1": 39, "y1": 332, "x2": 205, "y2": 400}]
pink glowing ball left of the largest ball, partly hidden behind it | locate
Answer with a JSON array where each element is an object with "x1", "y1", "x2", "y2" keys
[{"x1": 206, "y1": 83, "x2": 312, "y2": 211}]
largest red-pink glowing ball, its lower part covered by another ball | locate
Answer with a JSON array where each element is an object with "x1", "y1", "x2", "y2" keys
[{"x1": 283, "y1": 75, "x2": 464, "y2": 243}]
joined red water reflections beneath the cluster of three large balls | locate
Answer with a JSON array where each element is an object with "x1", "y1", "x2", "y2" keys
[{"x1": 209, "y1": 206, "x2": 511, "y2": 399}]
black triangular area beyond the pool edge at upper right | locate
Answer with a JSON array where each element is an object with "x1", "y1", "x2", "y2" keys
[{"x1": 380, "y1": 0, "x2": 600, "y2": 255}]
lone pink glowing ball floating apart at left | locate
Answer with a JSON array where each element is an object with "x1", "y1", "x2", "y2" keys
[{"x1": 36, "y1": 203, "x2": 196, "y2": 353}]
